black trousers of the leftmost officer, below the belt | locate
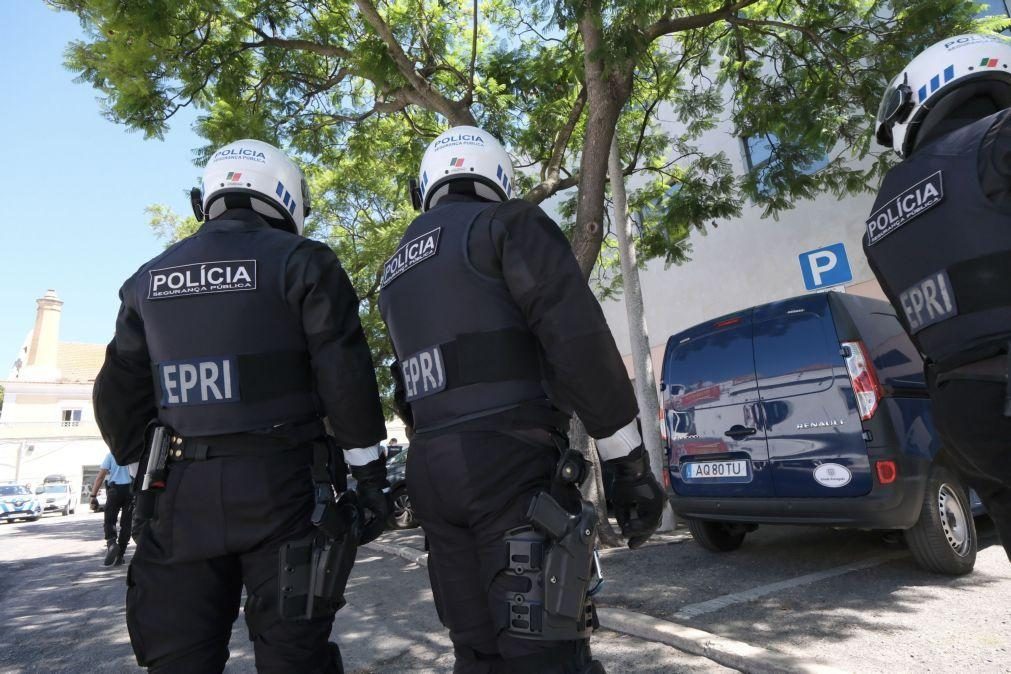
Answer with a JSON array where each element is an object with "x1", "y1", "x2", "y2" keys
[{"x1": 126, "y1": 448, "x2": 336, "y2": 674}]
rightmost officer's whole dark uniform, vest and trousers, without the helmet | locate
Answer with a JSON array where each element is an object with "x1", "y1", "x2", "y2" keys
[{"x1": 863, "y1": 110, "x2": 1011, "y2": 556}]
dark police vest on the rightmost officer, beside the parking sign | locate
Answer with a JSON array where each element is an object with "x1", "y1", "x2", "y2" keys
[{"x1": 863, "y1": 110, "x2": 1011, "y2": 370}]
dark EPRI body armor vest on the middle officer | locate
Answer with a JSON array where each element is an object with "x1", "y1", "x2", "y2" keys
[{"x1": 379, "y1": 202, "x2": 547, "y2": 431}]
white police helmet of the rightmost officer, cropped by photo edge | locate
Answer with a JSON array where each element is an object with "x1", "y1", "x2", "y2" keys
[{"x1": 876, "y1": 33, "x2": 1011, "y2": 157}]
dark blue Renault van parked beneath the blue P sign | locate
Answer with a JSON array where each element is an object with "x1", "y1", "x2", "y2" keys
[{"x1": 661, "y1": 292, "x2": 977, "y2": 574}]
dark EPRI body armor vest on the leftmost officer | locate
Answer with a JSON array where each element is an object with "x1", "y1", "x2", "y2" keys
[{"x1": 133, "y1": 220, "x2": 318, "y2": 436}]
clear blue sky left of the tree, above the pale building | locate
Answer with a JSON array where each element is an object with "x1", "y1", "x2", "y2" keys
[{"x1": 0, "y1": 0, "x2": 203, "y2": 369}]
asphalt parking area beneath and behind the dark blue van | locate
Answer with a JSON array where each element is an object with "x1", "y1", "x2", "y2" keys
[{"x1": 386, "y1": 519, "x2": 1011, "y2": 673}]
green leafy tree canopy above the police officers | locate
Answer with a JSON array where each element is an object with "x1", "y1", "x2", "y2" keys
[{"x1": 57, "y1": 0, "x2": 1003, "y2": 412}]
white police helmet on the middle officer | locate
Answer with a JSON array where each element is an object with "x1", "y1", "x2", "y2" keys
[{"x1": 410, "y1": 126, "x2": 513, "y2": 211}]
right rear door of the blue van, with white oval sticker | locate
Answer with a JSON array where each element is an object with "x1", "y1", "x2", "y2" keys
[{"x1": 753, "y1": 293, "x2": 871, "y2": 498}]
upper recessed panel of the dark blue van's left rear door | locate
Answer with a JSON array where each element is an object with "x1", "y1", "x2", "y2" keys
[{"x1": 664, "y1": 322, "x2": 758, "y2": 410}]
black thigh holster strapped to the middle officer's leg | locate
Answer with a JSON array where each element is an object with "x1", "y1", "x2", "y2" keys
[{"x1": 497, "y1": 492, "x2": 596, "y2": 641}]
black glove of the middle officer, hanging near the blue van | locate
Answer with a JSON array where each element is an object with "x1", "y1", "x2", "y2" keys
[{"x1": 605, "y1": 446, "x2": 666, "y2": 550}]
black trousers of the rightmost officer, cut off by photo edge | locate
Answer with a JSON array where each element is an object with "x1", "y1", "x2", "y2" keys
[{"x1": 927, "y1": 369, "x2": 1011, "y2": 559}]
